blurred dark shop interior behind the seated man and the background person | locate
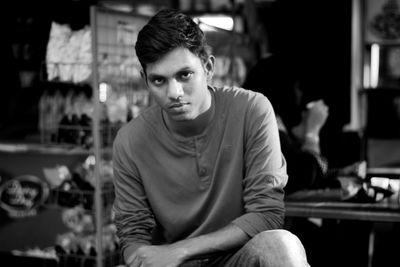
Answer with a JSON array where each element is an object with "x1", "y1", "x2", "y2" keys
[{"x1": 0, "y1": 0, "x2": 400, "y2": 267}]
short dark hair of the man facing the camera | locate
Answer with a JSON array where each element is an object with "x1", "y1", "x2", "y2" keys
[{"x1": 135, "y1": 8, "x2": 209, "y2": 70}]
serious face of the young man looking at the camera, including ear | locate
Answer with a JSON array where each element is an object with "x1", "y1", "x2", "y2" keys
[{"x1": 144, "y1": 48, "x2": 214, "y2": 121}]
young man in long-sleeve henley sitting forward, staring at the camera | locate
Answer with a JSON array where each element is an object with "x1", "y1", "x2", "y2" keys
[{"x1": 113, "y1": 9, "x2": 308, "y2": 267}]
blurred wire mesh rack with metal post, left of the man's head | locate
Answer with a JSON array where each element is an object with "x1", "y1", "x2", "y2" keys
[{"x1": 90, "y1": 6, "x2": 150, "y2": 267}]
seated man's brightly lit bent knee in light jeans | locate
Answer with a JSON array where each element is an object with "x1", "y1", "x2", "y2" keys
[{"x1": 246, "y1": 229, "x2": 308, "y2": 266}]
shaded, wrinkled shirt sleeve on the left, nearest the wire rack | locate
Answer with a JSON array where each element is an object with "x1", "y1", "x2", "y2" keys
[{"x1": 113, "y1": 133, "x2": 155, "y2": 256}]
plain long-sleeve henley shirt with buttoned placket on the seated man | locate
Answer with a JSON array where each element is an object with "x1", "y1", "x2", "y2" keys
[{"x1": 113, "y1": 87, "x2": 287, "y2": 255}]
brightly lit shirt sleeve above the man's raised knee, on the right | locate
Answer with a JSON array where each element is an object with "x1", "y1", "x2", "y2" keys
[{"x1": 233, "y1": 94, "x2": 288, "y2": 237}]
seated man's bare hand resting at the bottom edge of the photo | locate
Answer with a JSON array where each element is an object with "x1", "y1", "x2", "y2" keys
[{"x1": 127, "y1": 245, "x2": 185, "y2": 267}]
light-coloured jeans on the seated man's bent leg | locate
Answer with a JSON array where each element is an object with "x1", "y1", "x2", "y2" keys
[{"x1": 181, "y1": 230, "x2": 310, "y2": 267}]
